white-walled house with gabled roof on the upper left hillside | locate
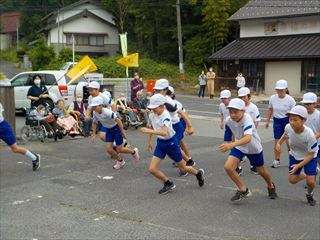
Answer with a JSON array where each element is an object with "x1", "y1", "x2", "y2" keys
[{"x1": 40, "y1": 0, "x2": 119, "y2": 56}]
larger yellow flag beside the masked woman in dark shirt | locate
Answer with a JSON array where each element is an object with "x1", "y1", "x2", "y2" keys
[{"x1": 67, "y1": 56, "x2": 98, "y2": 84}]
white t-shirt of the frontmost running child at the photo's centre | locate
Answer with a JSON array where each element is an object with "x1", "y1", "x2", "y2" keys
[{"x1": 148, "y1": 110, "x2": 176, "y2": 139}]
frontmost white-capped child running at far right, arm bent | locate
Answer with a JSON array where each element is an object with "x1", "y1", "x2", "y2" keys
[{"x1": 276, "y1": 106, "x2": 318, "y2": 206}]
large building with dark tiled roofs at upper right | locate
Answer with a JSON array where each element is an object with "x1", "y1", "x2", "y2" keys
[{"x1": 210, "y1": 0, "x2": 320, "y2": 95}]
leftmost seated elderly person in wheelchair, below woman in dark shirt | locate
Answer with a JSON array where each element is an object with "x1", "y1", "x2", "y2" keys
[{"x1": 28, "y1": 104, "x2": 59, "y2": 138}]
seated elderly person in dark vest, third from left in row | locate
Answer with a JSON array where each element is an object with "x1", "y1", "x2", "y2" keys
[{"x1": 68, "y1": 94, "x2": 92, "y2": 137}]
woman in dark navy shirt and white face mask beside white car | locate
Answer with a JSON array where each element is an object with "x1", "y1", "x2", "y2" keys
[{"x1": 27, "y1": 75, "x2": 49, "y2": 107}]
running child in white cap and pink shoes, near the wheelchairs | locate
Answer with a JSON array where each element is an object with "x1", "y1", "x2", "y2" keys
[{"x1": 90, "y1": 96, "x2": 140, "y2": 169}]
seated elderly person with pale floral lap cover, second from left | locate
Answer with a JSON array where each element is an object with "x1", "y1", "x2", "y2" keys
[{"x1": 52, "y1": 99, "x2": 80, "y2": 135}]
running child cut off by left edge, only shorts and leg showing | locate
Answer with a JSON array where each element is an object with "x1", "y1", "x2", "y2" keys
[{"x1": 0, "y1": 103, "x2": 41, "y2": 171}]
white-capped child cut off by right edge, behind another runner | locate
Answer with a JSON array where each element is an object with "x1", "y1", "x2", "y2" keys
[{"x1": 301, "y1": 92, "x2": 320, "y2": 184}]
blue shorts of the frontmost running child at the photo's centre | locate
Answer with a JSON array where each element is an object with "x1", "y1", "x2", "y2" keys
[{"x1": 153, "y1": 137, "x2": 182, "y2": 162}]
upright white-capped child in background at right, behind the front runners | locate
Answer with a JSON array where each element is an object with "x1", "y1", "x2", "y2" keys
[{"x1": 266, "y1": 80, "x2": 296, "y2": 168}]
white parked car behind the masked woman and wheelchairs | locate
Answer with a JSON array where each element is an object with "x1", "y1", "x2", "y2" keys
[{"x1": 0, "y1": 71, "x2": 88, "y2": 110}]
